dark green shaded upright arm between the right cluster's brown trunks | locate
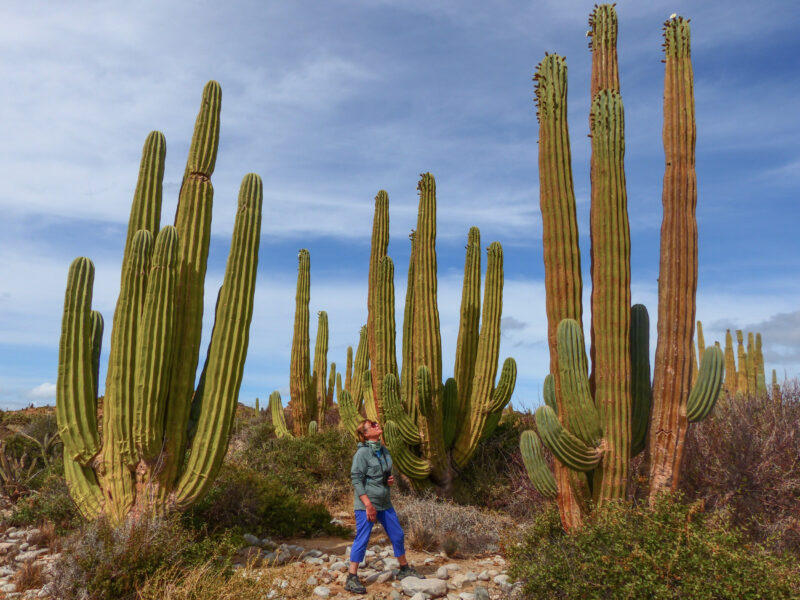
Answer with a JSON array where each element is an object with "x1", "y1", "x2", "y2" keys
[{"x1": 631, "y1": 304, "x2": 653, "y2": 456}]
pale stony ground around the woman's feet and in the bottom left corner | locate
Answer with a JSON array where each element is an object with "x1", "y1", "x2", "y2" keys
[{"x1": 0, "y1": 504, "x2": 516, "y2": 600}]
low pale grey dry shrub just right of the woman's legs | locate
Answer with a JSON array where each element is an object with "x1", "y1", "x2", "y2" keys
[{"x1": 393, "y1": 494, "x2": 517, "y2": 554}]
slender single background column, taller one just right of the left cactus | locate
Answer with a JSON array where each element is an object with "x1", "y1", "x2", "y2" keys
[{"x1": 289, "y1": 248, "x2": 313, "y2": 437}]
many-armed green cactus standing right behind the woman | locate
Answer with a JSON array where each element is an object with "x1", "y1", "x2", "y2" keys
[{"x1": 365, "y1": 173, "x2": 516, "y2": 496}]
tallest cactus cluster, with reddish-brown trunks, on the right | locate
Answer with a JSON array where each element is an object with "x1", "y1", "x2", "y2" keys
[{"x1": 521, "y1": 5, "x2": 723, "y2": 528}]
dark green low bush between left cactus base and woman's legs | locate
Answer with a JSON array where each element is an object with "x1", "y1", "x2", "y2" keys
[{"x1": 185, "y1": 464, "x2": 350, "y2": 537}]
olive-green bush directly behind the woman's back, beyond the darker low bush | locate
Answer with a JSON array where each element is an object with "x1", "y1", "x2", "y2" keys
[{"x1": 234, "y1": 422, "x2": 356, "y2": 505}]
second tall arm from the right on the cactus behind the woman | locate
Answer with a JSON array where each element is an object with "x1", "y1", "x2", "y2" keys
[{"x1": 453, "y1": 227, "x2": 481, "y2": 436}]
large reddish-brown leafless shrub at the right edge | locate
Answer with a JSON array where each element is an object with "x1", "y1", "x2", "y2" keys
[{"x1": 681, "y1": 381, "x2": 800, "y2": 552}]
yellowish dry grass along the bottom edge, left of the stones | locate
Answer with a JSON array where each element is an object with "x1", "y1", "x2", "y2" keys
[{"x1": 137, "y1": 563, "x2": 270, "y2": 600}]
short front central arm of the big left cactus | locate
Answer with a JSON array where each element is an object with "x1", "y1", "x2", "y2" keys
[{"x1": 133, "y1": 226, "x2": 178, "y2": 461}]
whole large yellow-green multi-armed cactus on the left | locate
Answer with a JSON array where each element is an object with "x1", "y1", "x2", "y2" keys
[{"x1": 56, "y1": 81, "x2": 263, "y2": 522}]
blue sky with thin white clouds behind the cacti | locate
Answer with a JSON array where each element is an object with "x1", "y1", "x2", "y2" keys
[{"x1": 0, "y1": 0, "x2": 800, "y2": 408}]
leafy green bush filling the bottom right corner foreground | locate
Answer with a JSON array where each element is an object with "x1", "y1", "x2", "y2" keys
[{"x1": 509, "y1": 497, "x2": 800, "y2": 599}]
